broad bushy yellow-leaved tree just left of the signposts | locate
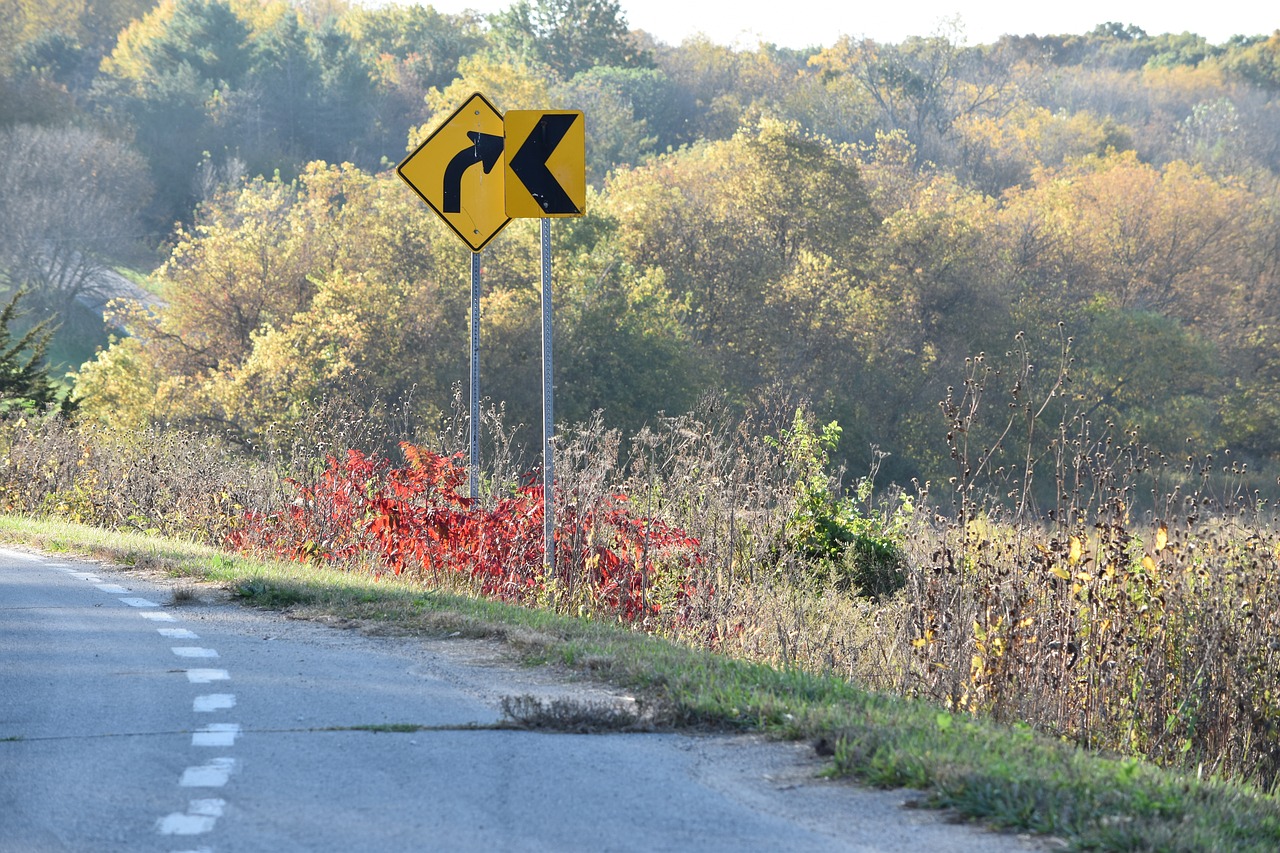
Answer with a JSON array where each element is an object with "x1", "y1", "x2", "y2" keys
[{"x1": 76, "y1": 163, "x2": 466, "y2": 439}]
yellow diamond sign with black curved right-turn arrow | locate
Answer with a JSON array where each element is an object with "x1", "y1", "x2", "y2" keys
[{"x1": 396, "y1": 92, "x2": 511, "y2": 252}]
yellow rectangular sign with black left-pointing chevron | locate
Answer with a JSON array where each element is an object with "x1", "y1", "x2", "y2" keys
[{"x1": 503, "y1": 110, "x2": 586, "y2": 219}]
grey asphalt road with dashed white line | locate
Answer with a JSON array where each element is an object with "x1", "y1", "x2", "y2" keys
[{"x1": 0, "y1": 549, "x2": 1029, "y2": 853}]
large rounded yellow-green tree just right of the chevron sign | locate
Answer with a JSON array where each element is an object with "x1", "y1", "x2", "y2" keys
[{"x1": 603, "y1": 120, "x2": 877, "y2": 432}]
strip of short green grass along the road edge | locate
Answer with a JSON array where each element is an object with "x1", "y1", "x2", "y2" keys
[{"x1": 0, "y1": 516, "x2": 1280, "y2": 853}]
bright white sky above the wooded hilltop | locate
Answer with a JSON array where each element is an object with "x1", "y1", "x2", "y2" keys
[{"x1": 422, "y1": 0, "x2": 1280, "y2": 47}]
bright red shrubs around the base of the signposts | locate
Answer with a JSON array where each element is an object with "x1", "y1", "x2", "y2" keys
[{"x1": 222, "y1": 442, "x2": 701, "y2": 621}]
